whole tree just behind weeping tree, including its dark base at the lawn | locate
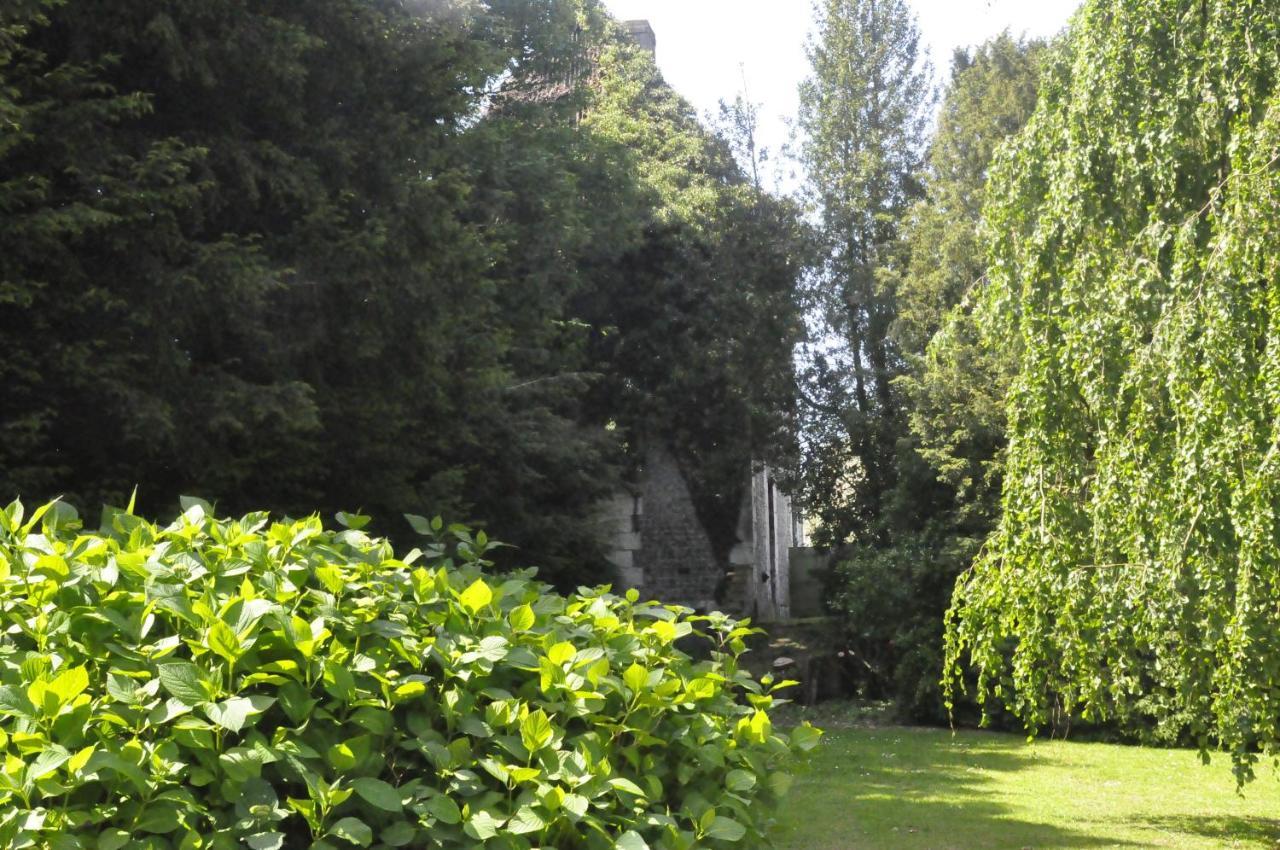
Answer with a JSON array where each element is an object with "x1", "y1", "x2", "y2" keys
[{"x1": 831, "y1": 35, "x2": 1039, "y2": 721}]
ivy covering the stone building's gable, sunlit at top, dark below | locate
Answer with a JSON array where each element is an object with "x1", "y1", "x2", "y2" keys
[{"x1": 577, "y1": 46, "x2": 808, "y2": 562}]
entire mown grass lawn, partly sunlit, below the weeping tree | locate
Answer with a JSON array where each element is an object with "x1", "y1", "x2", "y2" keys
[{"x1": 776, "y1": 711, "x2": 1280, "y2": 850}]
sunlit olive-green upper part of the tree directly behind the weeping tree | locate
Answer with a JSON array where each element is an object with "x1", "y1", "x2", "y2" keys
[{"x1": 892, "y1": 38, "x2": 1046, "y2": 539}]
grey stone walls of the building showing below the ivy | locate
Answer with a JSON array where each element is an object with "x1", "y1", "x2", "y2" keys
[{"x1": 602, "y1": 447, "x2": 805, "y2": 622}]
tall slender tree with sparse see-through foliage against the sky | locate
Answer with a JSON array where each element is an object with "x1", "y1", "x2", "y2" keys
[{"x1": 799, "y1": 0, "x2": 932, "y2": 543}]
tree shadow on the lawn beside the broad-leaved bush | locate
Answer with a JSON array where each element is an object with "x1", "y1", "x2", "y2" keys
[{"x1": 777, "y1": 728, "x2": 1140, "y2": 850}]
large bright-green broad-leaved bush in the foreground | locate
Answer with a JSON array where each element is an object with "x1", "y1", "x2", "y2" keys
[{"x1": 0, "y1": 501, "x2": 819, "y2": 850}]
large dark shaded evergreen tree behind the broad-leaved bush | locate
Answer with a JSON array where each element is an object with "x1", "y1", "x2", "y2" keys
[{"x1": 0, "y1": 0, "x2": 611, "y2": 578}]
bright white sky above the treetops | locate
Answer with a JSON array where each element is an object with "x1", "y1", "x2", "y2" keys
[{"x1": 604, "y1": 0, "x2": 1080, "y2": 186}]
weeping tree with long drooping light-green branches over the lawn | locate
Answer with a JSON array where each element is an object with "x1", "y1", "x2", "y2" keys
[{"x1": 947, "y1": 0, "x2": 1280, "y2": 781}]
